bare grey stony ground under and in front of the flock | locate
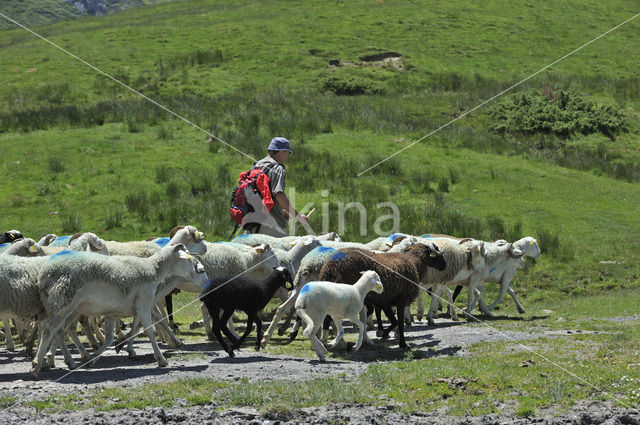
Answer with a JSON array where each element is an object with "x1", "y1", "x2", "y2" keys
[{"x1": 0, "y1": 322, "x2": 640, "y2": 425}]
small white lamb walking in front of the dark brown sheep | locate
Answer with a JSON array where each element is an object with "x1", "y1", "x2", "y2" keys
[{"x1": 295, "y1": 270, "x2": 383, "y2": 361}]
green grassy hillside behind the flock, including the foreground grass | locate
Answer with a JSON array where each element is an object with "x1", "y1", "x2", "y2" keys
[{"x1": 0, "y1": 0, "x2": 640, "y2": 415}]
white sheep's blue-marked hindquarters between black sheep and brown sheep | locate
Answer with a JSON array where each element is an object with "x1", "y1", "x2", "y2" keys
[{"x1": 261, "y1": 242, "x2": 336, "y2": 348}]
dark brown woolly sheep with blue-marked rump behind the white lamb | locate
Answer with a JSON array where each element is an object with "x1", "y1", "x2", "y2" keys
[{"x1": 319, "y1": 244, "x2": 446, "y2": 348}]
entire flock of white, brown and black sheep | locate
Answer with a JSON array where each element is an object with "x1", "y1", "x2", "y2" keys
[{"x1": 0, "y1": 226, "x2": 540, "y2": 379}]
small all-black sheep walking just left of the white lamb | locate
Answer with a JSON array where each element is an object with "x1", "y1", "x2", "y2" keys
[{"x1": 200, "y1": 267, "x2": 293, "y2": 357}]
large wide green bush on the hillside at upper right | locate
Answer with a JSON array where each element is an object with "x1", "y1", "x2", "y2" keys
[{"x1": 488, "y1": 89, "x2": 628, "y2": 138}]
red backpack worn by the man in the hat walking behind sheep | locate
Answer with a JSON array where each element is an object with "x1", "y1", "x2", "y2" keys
[{"x1": 229, "y1": 164, "x2": 277, "y2": 227}]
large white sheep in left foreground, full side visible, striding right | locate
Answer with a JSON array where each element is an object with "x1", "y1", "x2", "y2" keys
[{"x1": 31, "y1": 244, "x2": 207, "y2": 379}]
